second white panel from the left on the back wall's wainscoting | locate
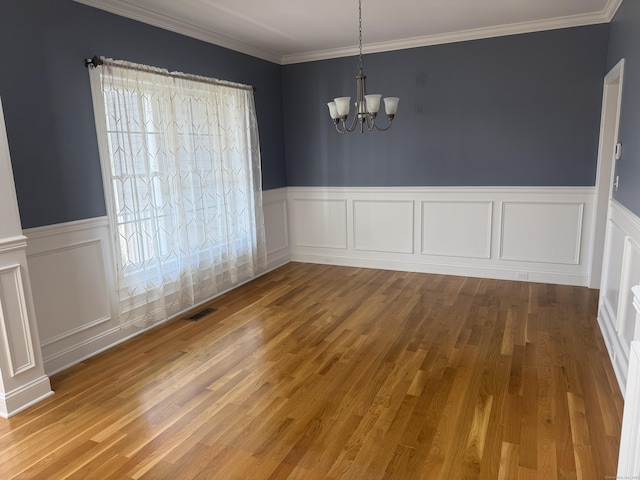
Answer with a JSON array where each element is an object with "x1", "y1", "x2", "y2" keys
[{"x1": 353, "y1": 200, "x2": 414, "y2": 253}]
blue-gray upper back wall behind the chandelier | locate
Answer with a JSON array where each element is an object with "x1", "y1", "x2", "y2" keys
[{"x1": 282, "y1": 25, "x2": 608, "y2": 186}]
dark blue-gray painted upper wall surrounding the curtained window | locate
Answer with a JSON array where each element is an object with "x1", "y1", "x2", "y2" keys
[{"x1": 0, "y1": 0, "x2": 286, "y2": 228}]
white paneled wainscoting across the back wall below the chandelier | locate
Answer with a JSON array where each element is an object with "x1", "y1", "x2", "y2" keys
[{"x1": 288, "y1": 187, "x2": 595, "y2": 286}]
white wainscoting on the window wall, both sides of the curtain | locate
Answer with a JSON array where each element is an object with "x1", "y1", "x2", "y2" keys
[{"x1": 24, "y1": 189, "x2": 289, "y2": 375}]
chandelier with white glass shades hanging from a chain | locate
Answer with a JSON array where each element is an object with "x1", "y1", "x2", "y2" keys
[{"x1": 327, "y1": 0, "x2": 400, "y2": 133}]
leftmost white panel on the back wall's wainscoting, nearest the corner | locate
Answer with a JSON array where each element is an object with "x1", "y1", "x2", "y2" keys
[{"x1": 292, "y1": 199, "x2": 347, "y2": 249}]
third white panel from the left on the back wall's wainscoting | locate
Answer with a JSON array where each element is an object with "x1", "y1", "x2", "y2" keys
[{"x1": 421, "y1": 201, "x2": 493, "y2": 258}]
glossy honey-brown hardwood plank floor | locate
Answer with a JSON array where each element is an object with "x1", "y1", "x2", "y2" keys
[{"x1": 0, "y1": 263, "x2": 623, "y2": 480}]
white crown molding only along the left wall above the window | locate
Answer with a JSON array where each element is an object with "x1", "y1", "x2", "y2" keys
[{"x1": 74, "y1": 0, "x2": 282, "y2": 64}]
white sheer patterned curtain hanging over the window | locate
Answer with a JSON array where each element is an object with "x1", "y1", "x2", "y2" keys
[{"x1": 89, "y1": 60, "x2": 266, "y2": 326}]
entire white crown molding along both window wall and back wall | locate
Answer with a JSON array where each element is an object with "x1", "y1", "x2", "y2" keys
[{"x1": 74, "y1": 0, "x2": 623, "y2": 65}]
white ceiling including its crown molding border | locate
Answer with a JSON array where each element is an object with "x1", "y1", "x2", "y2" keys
[{"x1": 75, "y1": 0, "x2": 622, "y2": 64}]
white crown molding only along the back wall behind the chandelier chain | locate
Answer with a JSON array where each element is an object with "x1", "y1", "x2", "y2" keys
[{"x1": 281, "y1": 7, "x2": 623, "y2": 65}]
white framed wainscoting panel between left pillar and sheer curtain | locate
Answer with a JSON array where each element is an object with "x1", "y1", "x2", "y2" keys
[{"x1": 29, "y1": 239, "x2": 111, "y2": 346}]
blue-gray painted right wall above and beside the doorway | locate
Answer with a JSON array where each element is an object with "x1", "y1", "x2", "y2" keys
[{"x1": 607, "y1": 0, "x2": 640, "y2": 216}]
